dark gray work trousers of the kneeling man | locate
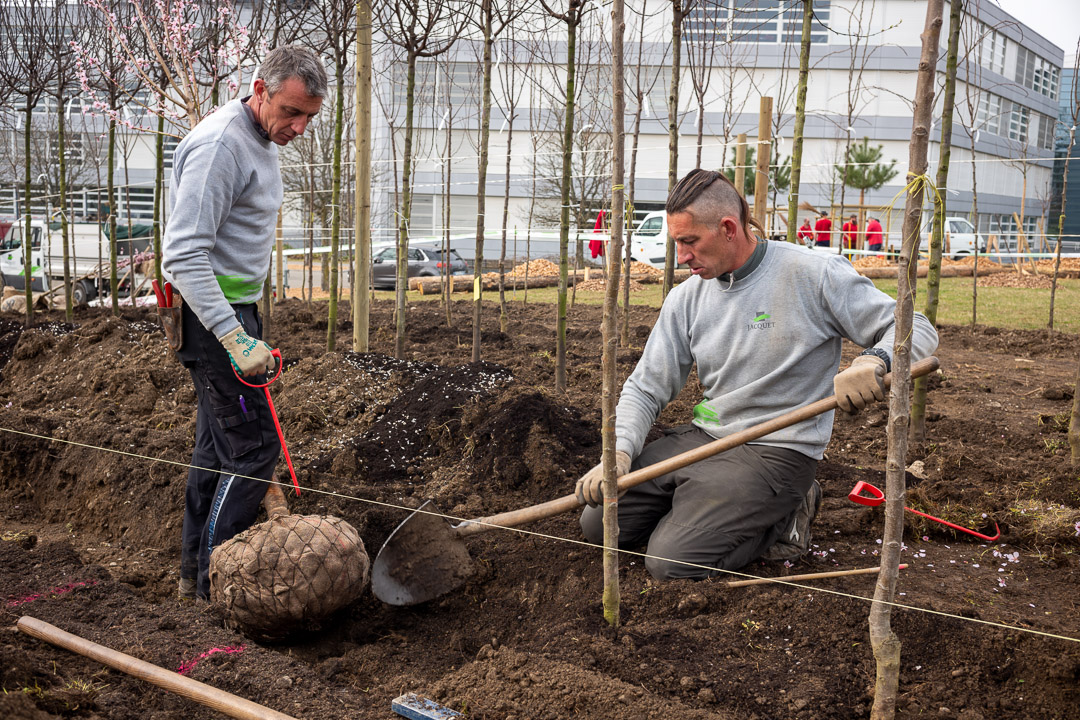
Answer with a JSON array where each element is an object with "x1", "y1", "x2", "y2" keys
[{"x1": 581, "y1": 425, "x2": 818, "y2": 580}]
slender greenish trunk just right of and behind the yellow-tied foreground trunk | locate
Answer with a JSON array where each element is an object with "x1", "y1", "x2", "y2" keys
[{"x1": 907, "y1": 0, "x2": 959, "y2": 446}]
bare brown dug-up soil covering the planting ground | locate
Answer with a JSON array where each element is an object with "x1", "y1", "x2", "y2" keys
[{"x1": 0, "y1": 300, "x2": 1080, "y2": 720}]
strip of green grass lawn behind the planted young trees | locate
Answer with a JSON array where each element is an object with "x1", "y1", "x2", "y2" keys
[{"x1": 365, "y1": 277, "x2": 1080, "y2": 332}]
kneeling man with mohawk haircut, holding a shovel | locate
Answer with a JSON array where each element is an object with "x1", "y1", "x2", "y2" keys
[{"x1": 577, "y1": 169, "x2": 937, "y2": 579}]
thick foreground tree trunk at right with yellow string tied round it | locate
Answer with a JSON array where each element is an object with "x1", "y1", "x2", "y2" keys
[{"x1": 869, "y1": 0, "x2": 943, "y2": 720}]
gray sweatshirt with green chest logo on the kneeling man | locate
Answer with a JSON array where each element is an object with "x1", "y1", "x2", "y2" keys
[{"x1": 616, "y1": 242, "x2": 937, "y2": 460}]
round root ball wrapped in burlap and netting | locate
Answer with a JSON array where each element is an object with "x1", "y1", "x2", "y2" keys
[{"x1": 210, "y1": 515, "x2": 370, "y2": 640}]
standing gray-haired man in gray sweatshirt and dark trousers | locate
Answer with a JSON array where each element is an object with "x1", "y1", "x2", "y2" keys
[{"x1": 162, "y1": 45, "x2": 326, "y2": 599}]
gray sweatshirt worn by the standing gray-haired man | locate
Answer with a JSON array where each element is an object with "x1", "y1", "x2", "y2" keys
[{"x1": 162, "y1": 100, "x2": 282, "y2": 338}]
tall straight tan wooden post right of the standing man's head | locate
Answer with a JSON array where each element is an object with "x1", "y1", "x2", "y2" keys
[{"x1": 352, "y1": 0, "x2": 372, "y2": 353}]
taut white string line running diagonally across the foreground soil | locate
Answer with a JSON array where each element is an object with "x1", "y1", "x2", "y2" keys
[{"x1": 0, "y1": 426, "x2": 1080, "y2": 642}]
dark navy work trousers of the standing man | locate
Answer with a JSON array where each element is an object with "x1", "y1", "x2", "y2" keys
[{"x1": 177, "y1": 304, "x2": 281, "y2": 598}]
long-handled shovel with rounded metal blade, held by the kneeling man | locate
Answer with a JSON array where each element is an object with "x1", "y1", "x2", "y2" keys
[{"x1": 372, "y1": 357, "x2": 939, "y2": 606}]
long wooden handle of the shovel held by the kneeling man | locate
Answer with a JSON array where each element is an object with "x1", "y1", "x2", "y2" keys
[{"x1": 455, "y1": 356, "x2": 939, "y2": 536}]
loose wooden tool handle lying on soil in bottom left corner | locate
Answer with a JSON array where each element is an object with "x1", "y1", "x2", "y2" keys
[{"x1": 17, "y1": 615, "x2": 296, "y2": 720}]
